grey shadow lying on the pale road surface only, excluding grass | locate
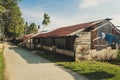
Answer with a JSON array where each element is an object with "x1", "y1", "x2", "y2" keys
[{"x1": 9, "y1": 45, "x2": 50, "y2": 64}]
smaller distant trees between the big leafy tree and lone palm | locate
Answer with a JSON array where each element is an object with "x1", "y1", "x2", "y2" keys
[{"x1": 25, "y1": 22, "x2": 38, "y2": 34}]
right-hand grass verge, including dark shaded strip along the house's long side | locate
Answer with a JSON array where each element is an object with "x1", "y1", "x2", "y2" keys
[{"x1": 37, "y1": 50, "x2": 120, "y2": 80}]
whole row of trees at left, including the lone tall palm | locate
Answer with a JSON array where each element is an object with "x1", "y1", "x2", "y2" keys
[{"x1": 0, "y1": 0, "x2": 50, "y2": 39}]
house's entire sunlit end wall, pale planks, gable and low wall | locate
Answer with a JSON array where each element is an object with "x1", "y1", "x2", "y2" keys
[{"x1": 75, "y1": 22, "x2": 118, "y2": 61}]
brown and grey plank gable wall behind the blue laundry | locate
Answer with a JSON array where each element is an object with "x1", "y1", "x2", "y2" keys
[{"x1": 91, "y1": 21, "x2": 116, "y2": 50}]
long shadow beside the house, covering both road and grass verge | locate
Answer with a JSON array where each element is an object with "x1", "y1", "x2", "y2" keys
[{"x1": 9, "y1": 45, "x2": 74, "y2": 64}]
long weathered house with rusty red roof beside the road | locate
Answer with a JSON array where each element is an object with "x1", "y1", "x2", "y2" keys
[{"x1": 23, "y1": 18, "x2": 120, "y2": 61}]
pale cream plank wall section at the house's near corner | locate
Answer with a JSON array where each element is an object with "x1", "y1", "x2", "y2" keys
[{"x1": 75, "y1": 32, "x2": 91, "y2": 61}]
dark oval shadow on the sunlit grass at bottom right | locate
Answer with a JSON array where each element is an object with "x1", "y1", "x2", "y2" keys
[{"x1": 82, "y1": 71, "x2": 114, "y2": 80}]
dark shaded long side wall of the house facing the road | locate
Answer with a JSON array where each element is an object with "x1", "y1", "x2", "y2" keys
[{"x1": 31, "y1": 37, "x2": 74, "y2": 57}]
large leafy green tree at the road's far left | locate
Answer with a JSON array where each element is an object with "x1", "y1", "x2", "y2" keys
[{"x1": 2, "y1": 0, "x2": 24, "y2": 38}]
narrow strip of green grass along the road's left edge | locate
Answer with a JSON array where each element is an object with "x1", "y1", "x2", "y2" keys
[{"x1": 0, "y1": 48, "x2": 4, "y2": 80}]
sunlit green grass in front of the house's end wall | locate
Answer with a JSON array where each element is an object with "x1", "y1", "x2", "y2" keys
[{"x1": 58, "y1": 61, "x2": 120, "y2": 80}]
